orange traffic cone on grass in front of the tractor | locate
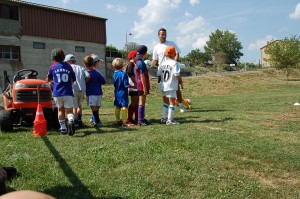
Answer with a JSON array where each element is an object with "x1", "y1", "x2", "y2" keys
[{"x1": 33, "y1": 104, "x2": 47, "y2": 137}]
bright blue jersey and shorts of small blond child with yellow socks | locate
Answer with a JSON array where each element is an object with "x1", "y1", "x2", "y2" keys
[{"x1": 114, "y1": 70, "x2": 129, "y2": 107}]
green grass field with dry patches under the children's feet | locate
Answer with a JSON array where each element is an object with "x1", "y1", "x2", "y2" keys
[{"x1": 0, "y1": 70, "x2": 300, "y2": 199}]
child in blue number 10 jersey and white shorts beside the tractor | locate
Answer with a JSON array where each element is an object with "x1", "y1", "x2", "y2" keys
[{"x1": 47, "y1": 48, "x2": 76, "y2": 135}]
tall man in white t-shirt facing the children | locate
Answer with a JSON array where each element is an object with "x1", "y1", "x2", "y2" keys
[{"x1": 152, "y1": 28, "x2": 185, "y2": 113}]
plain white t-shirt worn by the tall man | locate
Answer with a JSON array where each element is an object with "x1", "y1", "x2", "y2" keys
[{"x1": 152, "y1": 41, "x2": 180, "y2": 65}]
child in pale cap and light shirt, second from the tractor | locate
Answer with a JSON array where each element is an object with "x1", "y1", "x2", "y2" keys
[{"x1": 65, "y1": 54, "x2": 90, "y2": 128}]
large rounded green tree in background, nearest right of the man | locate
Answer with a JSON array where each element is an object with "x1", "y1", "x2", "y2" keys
[{"x1": 204, "y1": 29, "x2": 243, "y2": 64}]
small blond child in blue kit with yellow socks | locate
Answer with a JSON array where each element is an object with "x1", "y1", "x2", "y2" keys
[{"x1": 112, "y1": 58, "x2": 134, "y2": 126}]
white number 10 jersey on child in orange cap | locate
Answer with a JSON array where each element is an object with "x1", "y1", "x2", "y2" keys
[{"x1": 157, "y1": 58, "x2": 180, "y2": 91}]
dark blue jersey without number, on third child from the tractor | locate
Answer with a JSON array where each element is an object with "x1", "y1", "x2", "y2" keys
[{"x1": 86, "y1": 69, "x2": 106, "y2": 96}]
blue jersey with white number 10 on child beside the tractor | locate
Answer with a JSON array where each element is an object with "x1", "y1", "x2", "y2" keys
[{"x1": 47, "y1": 62, "x2": 76, "y2": 97}]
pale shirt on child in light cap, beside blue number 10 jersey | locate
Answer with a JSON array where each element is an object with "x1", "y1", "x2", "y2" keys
[{"x1": 71, "y1": 64, "x2": 89, "y2": 92}]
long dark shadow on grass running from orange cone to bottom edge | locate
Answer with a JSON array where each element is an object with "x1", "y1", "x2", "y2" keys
[{"x1": 42, "y1": 136, "x2": 122, "y2": 199}]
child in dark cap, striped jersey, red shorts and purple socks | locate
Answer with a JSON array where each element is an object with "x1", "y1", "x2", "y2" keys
[{"x1": 136, "y1": 45, "x2": 150, "y2": 126}]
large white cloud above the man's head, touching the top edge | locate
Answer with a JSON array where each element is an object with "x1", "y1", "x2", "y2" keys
[{"x1": 132, "y1": 0, "x2": 181, "y2": 39}]
